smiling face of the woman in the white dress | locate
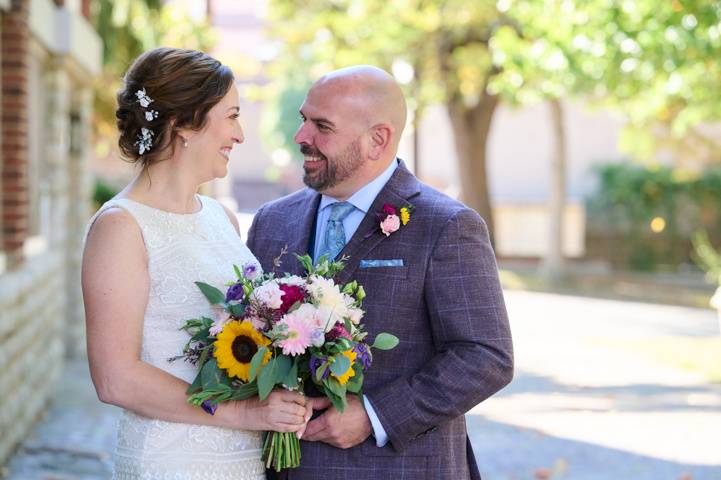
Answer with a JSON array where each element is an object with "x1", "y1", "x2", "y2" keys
[{"x1": 190, "y1": 86, "x2": 244, "y2": 181}]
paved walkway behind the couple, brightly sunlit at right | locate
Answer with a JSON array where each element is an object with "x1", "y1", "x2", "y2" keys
[{"x1": 4, "y1": 291, "x2": 721, "y2": 480}]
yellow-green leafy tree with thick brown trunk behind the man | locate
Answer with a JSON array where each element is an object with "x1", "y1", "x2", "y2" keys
[{"x1": 269, "y1": 0, "x2": 507, "y2": 240}]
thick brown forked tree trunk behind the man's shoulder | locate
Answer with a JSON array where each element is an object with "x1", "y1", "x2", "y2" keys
[{"x1": 446, "y1": 92, "x2": 499, "y2": 243}]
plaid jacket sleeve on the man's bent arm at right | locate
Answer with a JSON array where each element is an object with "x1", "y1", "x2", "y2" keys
[{"x1": 364, "y1": 209, "x2": 513, "y2": 452}]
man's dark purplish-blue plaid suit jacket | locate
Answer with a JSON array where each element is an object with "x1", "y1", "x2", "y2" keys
[{"x1": 248, "y1": 163, "x2": 513, "y2": 480}]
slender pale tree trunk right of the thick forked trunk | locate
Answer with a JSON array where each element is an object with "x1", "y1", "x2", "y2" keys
[{"x1": 541, "y1": 98, "x2": 566, "y2": 282}]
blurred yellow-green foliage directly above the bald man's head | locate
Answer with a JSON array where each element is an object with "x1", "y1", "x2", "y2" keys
[{"x1": 264, "y1": 0, "x2": 505, "y2": 159}]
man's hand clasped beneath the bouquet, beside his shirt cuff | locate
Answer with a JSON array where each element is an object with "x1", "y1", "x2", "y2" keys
[{"x1": 303, "y1": 395, "x2": 372, "y2": 448}]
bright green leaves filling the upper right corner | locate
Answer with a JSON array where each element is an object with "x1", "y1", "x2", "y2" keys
[{"x1": 490, "y1": 0, "x2": 721, "y2": 161}]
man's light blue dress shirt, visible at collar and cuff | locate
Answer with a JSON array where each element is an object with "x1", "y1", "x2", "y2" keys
[{"x1": 313, "y1": 160, "x2": 398, "y2": 447}]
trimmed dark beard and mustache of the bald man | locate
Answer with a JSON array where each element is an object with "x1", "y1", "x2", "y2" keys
[{"x1": 300, "y1": 139, "x2": 364, "y2": 192}]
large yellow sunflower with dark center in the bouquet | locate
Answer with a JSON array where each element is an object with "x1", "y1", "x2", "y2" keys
[{"x1": 213, "y1": 320, "x2": 271, "y2": 382}]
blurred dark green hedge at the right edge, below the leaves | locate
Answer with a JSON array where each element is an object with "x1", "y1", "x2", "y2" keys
[{"x1": 588, "y1": 163, "x2": 721, "y2": 270}]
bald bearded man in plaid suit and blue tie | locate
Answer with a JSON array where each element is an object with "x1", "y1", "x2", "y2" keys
[{"x1": 248, "y1": 66, "x2": 513, "y2": 480}]
